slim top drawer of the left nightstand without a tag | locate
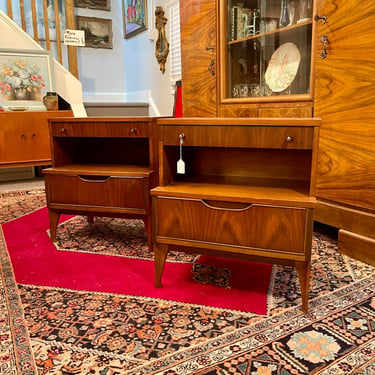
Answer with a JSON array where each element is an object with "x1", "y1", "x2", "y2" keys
[{"x1": 52, "y1": 122, "x2": 148, "y2": 137}]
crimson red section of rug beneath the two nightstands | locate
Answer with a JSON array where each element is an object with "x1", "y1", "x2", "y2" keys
[{"x1": 3, "y1": 207, "x2": 272, "y2": 314}]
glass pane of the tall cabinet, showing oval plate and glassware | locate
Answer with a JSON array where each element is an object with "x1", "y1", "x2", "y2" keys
[{"x1": 224, "y1": 0, "x2": 313, "y2": 98}]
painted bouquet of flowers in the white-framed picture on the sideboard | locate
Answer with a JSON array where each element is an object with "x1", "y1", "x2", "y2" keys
[{"x1": 0, "y1": 59, "x2": 45, "y2": 100}]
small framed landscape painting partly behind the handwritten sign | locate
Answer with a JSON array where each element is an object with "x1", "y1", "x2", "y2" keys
[{"x1": 76, "y1": 16, "x2": 112, "y2": 48}]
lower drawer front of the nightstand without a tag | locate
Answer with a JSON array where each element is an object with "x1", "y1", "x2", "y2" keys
[{"x1": 45, "y1": 175, "x2": 148, "y2": 209}]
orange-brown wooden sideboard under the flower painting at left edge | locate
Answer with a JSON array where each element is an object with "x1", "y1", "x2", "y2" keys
[{"x1": 0, "y1": 111, "x2": 73, "y2": 168}]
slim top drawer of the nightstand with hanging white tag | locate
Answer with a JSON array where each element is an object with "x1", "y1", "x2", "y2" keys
[{"x1": 163, "y1": 125, "x2": 314, "y2": 149}]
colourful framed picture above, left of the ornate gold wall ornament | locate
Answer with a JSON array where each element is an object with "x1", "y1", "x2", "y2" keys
[{"x1": 121, "y1": 0, "x2": 147, "y2": 39}]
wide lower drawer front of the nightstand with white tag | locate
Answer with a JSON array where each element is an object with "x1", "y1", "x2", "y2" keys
[{"x1": 155, "y1": 197, "x2": 306, "y2": 254}]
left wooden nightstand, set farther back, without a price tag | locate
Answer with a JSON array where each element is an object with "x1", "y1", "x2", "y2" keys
[{"x1": 43, "y1": 117, "x2": 158, "y2": 249}]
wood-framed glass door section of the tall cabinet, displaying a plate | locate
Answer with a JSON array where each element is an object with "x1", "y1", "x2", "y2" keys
[{"x1": 218, "y1": 0, "x2": 313, "y2": 113}]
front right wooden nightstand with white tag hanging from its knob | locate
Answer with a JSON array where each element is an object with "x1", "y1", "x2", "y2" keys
[{"x1": 151, "y1": 118, "x2": 320, "y2": 311}]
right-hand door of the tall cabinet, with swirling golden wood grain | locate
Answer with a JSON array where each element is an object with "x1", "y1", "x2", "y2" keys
[{"x1": 314, "y1": 0, "x2": 375, "y2": 210}]
